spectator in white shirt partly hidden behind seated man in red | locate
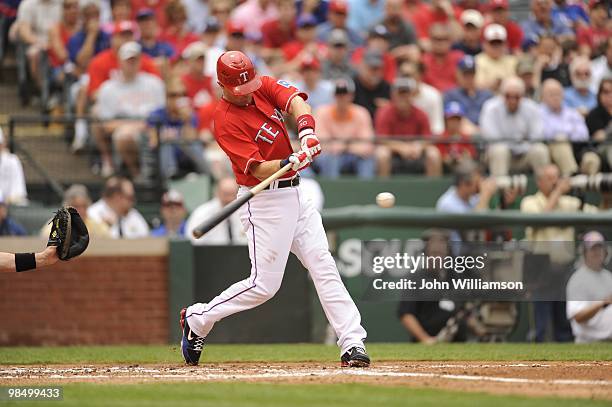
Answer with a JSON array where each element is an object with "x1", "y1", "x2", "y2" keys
[{"x1": 399, "y1": 61, "x2": 444, "y2": 135}]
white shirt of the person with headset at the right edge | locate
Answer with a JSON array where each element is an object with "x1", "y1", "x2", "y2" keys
[{"x1": 566, "y1": 265, "x2": 612, "y2": 343}]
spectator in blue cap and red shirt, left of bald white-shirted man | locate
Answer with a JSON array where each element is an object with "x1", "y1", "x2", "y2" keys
[{"x1": 436, "y1": 101, "x2": 476, "y2": 169}]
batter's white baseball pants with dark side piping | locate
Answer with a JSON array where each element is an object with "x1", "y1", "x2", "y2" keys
[{"x1": 187, "y1": 186, "x2": 367, "y2": 355}]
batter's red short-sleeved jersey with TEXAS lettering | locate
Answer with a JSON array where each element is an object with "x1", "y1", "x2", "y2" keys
[{"x1": 214, "y1": 76, "x2": 308, "y2": 186}]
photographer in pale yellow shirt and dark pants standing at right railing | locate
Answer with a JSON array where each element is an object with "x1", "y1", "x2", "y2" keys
[{"x1": 521, "y1": 164, "x2": 591, "y2": 342}]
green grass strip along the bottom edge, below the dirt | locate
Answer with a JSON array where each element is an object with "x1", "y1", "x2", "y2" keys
[{"x1": 3, "y1": 383, "x2": 610, "y2": 407}]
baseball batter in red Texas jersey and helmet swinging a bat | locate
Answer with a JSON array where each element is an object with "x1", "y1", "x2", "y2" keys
[{"x1": 181, "y1": 51, "x2": 370, "y2": 367}]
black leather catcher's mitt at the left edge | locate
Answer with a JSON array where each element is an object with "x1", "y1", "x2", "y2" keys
[{"x1": 47, "y1": 206, "x2": 89, "y2": 260}]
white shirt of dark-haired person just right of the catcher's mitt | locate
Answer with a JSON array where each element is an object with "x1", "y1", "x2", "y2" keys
[{"x1": 87, "y1": 199, "x2": 149, "y2": 239}]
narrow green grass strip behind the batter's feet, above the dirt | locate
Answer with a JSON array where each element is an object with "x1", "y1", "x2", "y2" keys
[{"x1": 0, "y1": 343, "x2": 612, "y2": 365}]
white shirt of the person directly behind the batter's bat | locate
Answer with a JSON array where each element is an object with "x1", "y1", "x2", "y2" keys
[{"x1": 185, "y1": 198, "x2": 247, "y2": 246}]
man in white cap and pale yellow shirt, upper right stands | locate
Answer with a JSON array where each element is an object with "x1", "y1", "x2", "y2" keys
[{"x1": 476, "y1": 24, "x2": 517, "y2": 91}]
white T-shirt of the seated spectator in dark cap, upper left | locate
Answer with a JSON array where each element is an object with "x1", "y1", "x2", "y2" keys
[{"x1": 96, "y1": 72, "x2": 166, "y2": 119}]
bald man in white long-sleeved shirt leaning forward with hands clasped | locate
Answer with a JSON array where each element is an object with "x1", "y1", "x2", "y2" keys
[{"x1": 480, "y1": 76, "x2": 550, "y2": 176}]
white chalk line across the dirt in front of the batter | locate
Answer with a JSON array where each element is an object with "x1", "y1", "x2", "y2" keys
[{"x1": 0, "y1": 365, "x2": 612, "y2": 387}]
